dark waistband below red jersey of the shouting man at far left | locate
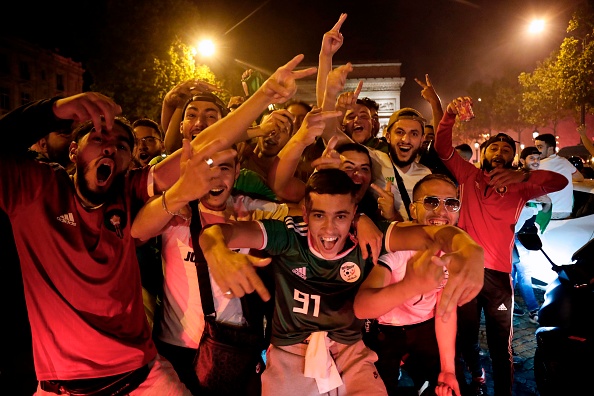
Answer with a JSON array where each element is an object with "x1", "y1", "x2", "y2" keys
[{"x1": 39, "y1": 364, "x2": 151, "y2": 396}]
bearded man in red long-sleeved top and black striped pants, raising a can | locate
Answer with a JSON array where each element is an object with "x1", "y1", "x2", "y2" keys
[{"x1": 435, "y1": 97, "x2": 567, "y2": 396}]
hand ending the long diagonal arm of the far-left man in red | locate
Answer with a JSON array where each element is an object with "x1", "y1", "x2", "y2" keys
[{"x1": 260, "y1": 54, "x2": 317, "y2": 103}]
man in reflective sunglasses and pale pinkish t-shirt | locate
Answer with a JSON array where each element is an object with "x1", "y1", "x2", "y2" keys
[{"x1": 354, "y1": 174, "x2": 460, "y2": 395}]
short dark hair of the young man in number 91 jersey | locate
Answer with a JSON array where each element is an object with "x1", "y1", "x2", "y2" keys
[{"x1": 305, "y1": 168, "x2": 359, "y2": 208}]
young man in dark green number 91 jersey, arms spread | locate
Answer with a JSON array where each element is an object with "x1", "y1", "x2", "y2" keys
[{"x1": 200, "y1": 169, "x2": 482, "y2": 395}]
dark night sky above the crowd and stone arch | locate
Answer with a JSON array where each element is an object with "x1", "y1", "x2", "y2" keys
[{"x1": 0, "y1": 0, "x2": 583, "y2": 112}]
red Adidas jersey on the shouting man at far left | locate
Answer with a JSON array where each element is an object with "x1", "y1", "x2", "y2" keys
[{"x1": 0, "y1": 158, "x2": 156, "y2": 380}]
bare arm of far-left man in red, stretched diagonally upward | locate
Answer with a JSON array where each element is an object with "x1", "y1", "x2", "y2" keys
[{"x1": 154, "y1": 55, "x2": 316, "y2": 192}]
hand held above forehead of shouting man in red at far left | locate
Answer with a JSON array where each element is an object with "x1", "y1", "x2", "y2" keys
[{"x1": 53, "y1": 92, "x2": 122, "y2": 131}]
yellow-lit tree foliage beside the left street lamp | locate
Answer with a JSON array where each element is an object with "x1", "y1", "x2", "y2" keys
[{"x1": 87, "y1": 0, "x2": 225, "y2": 122}]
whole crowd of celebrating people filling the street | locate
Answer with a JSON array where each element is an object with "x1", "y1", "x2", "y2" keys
[{"x1": 0, "y1": 10, "x2": 591, "y2": 396}]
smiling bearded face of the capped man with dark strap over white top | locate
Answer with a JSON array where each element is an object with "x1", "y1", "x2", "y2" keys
[{"x1": 386, "y1": 119, "x2": 423, "y2": 171}]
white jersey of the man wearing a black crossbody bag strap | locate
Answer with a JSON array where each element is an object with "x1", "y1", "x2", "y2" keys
[{"x1": 157, "y1": 195, "x2": 289, "y2": 349}]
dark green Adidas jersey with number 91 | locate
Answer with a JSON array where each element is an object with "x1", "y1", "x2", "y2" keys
[{"x1": 260, "y1": 217, "x2": 386, "y2": 346}]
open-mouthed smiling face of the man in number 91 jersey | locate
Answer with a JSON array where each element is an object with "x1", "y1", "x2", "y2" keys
[{"x1": 303, "y1": 192, "x2": 357, "y2": 260}]
